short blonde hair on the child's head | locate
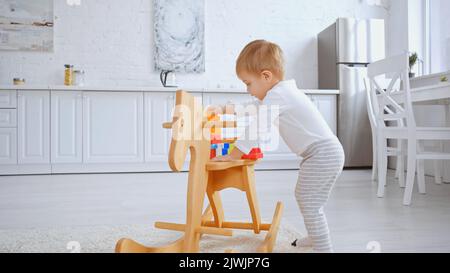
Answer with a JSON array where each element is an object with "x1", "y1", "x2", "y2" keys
[{"x1": 236, "y1": 40, "x2": 284, "y2": 79}]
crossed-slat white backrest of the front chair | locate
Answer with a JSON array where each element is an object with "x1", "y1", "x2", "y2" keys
[{"x1": 368, "y1": 54, "x2": 416, "y2": 130}]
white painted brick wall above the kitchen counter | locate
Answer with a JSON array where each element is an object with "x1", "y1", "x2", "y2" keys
[{"x1": 0, "y1": 0, "x2": 388, "y2": 88}]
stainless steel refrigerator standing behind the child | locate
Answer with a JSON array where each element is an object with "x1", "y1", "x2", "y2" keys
[{"x1": 318, "y1": 18, "x2": 386, "y2": 168}]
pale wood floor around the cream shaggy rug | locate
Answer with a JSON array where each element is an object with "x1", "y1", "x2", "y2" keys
[{"x1": 0, "y1": 170, "x2": 450, "y2": 252}]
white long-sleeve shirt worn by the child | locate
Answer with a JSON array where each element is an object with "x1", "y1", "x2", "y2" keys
[{"x1": 235, "y1": 80, "x2": 336, "y2": 156}]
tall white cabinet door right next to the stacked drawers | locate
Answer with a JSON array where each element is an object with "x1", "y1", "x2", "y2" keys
[{"x1": 17, "y1": 90, "x2": 50, "y2": 164}]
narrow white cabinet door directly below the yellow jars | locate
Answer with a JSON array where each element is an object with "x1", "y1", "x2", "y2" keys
[{"x1": 51, "y1": 91, "x2": 83, "y2": 163}]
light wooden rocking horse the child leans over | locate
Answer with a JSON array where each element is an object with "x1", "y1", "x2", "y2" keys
[{"x1": 116, "y1": 91, "x2": 283, "y2": 253}]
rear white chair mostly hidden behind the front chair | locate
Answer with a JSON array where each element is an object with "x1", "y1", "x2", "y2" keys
[{"x1": 364, "y1": 78, "x2": 405, "y2": 188}]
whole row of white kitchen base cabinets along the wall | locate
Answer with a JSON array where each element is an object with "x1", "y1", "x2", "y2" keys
[{"x1": 0, "y1": 87, "x2": 337, "y2": 175}]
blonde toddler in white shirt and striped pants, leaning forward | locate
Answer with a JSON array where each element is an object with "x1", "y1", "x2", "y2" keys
[{"x1": 215, "y1": 40, "x2": 344, "y2": 252}]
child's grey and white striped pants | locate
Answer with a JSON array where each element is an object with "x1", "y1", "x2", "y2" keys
[{"x1": 295, "y1": 139, "x2": 345, "y2": 252}]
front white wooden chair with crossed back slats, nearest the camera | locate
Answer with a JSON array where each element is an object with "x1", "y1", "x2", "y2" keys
[{"x1": 368, "y1": 54, "x2": 450, "y2": 205}]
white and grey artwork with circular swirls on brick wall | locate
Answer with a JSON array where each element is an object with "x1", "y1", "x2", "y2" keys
[{"x1": 154, "y1": 0, "x2": 205, "y2": 73}]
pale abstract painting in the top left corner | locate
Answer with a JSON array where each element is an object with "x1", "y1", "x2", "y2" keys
[{"x1": 0, "y1": 0, "x2": 53, "y2": 51}]
